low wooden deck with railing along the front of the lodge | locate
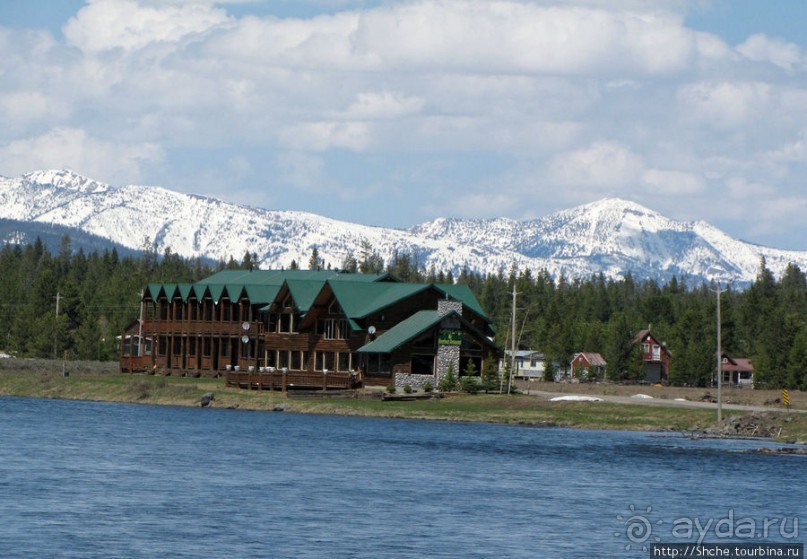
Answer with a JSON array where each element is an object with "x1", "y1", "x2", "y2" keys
[{"x1": 225, "y1": 371, "x2": 361, "y2": 392}]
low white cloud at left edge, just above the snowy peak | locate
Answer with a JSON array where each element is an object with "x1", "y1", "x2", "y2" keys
[{"x1": 0, "y1": 128, "x2": 165, "y2": 183}]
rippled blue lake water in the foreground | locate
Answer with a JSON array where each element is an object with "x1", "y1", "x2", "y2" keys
[{"x1": 0, "y1": 398, "x2": 807, "y2": 559}]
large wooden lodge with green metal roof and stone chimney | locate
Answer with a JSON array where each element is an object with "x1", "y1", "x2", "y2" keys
[{"x1": 120, "y1": 270, "x2": 500, "y2": 389}]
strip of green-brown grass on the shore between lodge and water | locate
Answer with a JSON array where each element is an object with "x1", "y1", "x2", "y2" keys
[{"x1": 0, "y1": 359, "x2": 807, "y2": 441}]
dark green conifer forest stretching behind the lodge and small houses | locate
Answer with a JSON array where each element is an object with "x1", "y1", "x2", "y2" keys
[{"x1": 0, "y1": 236, "x2": 807, "y2": 389}]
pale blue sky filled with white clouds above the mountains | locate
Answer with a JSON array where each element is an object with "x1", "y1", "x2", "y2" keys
[{"x1": 0, "y1": 0, "x2": 807, "y2": 250}]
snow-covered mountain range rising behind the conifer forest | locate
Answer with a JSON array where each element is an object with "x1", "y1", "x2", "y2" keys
[{"x1": 0, "y1": 170, "x2": 807, "y2": 284}]
